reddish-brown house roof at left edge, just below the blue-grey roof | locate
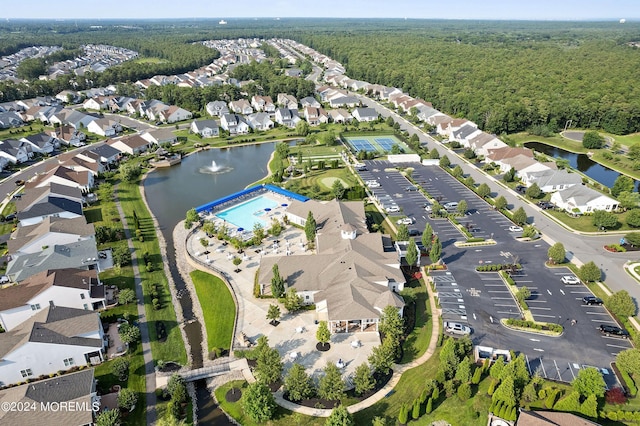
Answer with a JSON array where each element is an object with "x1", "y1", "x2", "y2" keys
[{"x1": 0, "y1": 268, "x2": 102, "y2": 311}]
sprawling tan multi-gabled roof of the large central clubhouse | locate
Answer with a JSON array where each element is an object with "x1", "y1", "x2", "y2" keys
[{"x1": 258, "y1": 200, "x2": 404, "y2": 320}]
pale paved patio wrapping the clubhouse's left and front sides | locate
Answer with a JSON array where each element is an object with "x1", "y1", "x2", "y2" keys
[{"x1": 187, "y1": 221, "x2": 380, "y2": 383}]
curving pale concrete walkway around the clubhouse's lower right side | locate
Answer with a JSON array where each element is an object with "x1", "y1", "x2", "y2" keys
[{"x1": 275, "y1": 268, "x2": 440, "y2": 417}]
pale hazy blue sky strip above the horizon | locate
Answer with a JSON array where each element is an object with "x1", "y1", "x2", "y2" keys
[{"x1": 0, "y1": 0, "x2": 640, "y2": 20}]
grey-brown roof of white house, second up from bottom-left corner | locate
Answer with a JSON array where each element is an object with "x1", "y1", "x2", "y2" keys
[{"x1": 0, "y1": 306, "x2": 103, "y2": 357}]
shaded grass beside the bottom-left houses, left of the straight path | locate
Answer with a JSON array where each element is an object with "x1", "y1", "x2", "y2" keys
[{"x1": 95, "y1": 343, "x2": 147, "y2": 426}]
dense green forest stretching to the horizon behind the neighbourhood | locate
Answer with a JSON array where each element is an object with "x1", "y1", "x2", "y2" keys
[{"x1": 0, "y1": 19, "x2": 640, "y2": 134}]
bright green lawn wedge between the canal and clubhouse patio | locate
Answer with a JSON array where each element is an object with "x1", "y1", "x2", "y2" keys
[{"x1": 191, "y1": 271, "x2": 236, "y2": 352}]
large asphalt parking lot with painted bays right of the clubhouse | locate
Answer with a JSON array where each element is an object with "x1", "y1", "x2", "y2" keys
[{"x1": 359, "y1": 160, "x2": 631, "y2": 381}]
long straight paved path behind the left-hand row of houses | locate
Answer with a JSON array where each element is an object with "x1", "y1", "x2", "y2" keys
[{"x1": 114, "y1": 186, "x2": 158, "y2": 425}]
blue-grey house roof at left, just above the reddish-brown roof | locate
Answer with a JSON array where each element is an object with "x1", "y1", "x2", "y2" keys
[{"x1": 7, "y1": 239, "x2": 98, "y2": 282}]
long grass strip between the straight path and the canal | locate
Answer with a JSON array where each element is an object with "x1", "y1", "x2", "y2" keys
[{"x1": 118, "y1": 182, "x2": 187, "y2": 365}]
